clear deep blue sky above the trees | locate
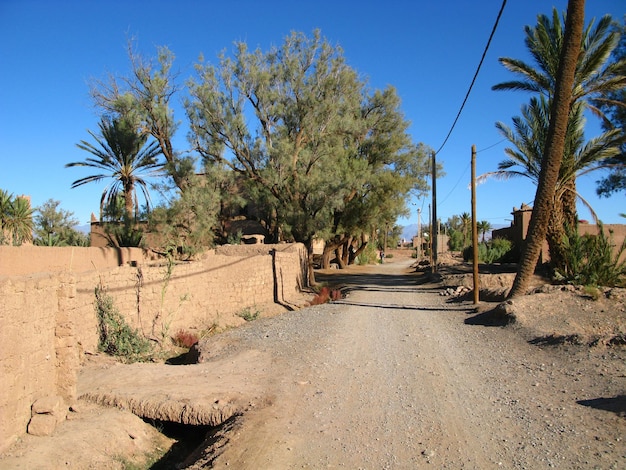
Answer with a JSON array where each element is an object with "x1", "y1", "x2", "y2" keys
[{"x1": 0, "y1": 0, "x2": 626, "y2": 231}]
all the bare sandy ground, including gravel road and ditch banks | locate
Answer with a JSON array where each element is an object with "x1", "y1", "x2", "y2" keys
[{"x1": 0, "y1": 248, "x2": 626, "y2": 469}]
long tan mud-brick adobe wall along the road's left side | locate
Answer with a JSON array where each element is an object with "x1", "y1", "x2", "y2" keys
[{"x1": 0, "y1": 244, "x2": 308, "y2": 451}]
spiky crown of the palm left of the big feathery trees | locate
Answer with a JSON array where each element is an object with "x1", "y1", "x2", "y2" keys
[{"x1": 65, "y1": 117, "x2": 164, "y2": 219}]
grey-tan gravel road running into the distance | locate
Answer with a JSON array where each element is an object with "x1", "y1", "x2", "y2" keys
[{"x1": 189, "y1": 260, "x2": 626, "y2": 470}]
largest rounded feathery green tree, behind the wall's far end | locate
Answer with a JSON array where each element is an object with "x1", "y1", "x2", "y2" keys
[{"x1": 186, "y1": 32, "x2": 428, "y2": 279}]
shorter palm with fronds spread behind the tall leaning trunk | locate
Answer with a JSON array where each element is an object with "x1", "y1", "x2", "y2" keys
[{"x1": 478, "y1": 96, "x2": 623, "y2": 267}]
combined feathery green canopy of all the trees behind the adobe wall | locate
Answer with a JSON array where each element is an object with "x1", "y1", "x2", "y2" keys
[{"x1": 78, "y1": 31, "x2": 430, "y2": 266}]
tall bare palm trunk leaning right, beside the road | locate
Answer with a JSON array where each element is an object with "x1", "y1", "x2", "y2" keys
[{"x1": 508, "y1": 0, "x2": 585, "y2": 298}]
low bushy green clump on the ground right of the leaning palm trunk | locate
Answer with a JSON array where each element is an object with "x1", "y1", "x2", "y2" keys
[{"x1": 555, "y1": 224, "x2": 626, "y2": 287}]
